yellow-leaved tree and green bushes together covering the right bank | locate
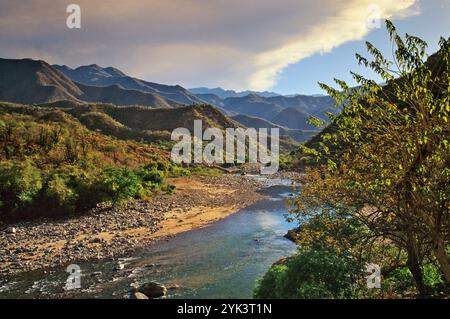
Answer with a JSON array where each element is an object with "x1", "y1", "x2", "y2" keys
[{"x1": 256, "y1": 21, "x2": 450, "y2": 298}]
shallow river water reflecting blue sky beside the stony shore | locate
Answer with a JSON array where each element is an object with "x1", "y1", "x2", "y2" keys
[{"x1": 0, "y1": 181, "x2": 296, "y2": 298}]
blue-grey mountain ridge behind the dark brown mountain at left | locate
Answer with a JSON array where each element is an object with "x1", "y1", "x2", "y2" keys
[{"x1": 53, "y1": 64, "x2": 204, "y2": 104}]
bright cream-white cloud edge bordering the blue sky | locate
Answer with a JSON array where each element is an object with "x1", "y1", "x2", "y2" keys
[{"x1": 249, "y1": 0, "x2": 415, "y2": 90}]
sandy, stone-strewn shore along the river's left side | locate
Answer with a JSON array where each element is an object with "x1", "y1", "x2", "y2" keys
[{"x1": 0, "y1": 175, "x2": 263, "y2": 276}]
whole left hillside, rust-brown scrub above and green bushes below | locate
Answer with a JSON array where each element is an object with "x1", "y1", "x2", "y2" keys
[{"x1": 0, "y1": 103, "x2": 190, "y2": 220}]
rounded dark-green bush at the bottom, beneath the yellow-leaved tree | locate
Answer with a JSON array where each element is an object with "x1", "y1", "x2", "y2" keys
[{"x1": 255, "y1": 248, "x2": 361, "y2": 299}]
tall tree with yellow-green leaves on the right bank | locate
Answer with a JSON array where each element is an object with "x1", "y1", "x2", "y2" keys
[{"x1": 296, "y1": 21, "x2": 450, "y2": 295}]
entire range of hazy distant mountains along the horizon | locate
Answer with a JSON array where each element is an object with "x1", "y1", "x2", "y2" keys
[{"x1": 0, "y1": 59, "x2": 339, "y2": 142}]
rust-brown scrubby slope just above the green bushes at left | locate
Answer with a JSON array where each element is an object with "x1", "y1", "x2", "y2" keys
[{"x1": 0, "y1": 102, "x2": 169, "y2": 167}]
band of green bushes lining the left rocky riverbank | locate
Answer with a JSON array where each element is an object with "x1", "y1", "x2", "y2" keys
[{"x1": 0, "y1": 161, "x2": 168, "y2": 220}]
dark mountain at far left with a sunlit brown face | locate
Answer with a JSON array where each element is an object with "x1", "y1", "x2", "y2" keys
[{"x1": 0, "y1": 59, "x2": 181, "y2": 108}]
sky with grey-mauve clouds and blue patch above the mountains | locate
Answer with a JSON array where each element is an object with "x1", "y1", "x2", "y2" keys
[{"x1": 0, "y1": 0, "x2": 450, "y2": 94}]
